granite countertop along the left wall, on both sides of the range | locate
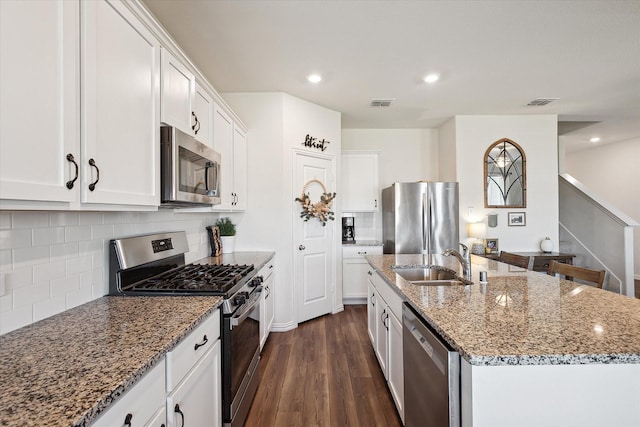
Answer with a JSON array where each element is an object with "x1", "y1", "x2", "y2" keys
[{"x1": 0, "y1": 252, "x2": 274, "y2": 426}]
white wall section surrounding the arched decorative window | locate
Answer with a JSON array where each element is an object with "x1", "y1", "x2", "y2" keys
[{"x1": 450, "y1": 115, "x2": 559, "y2": 251}]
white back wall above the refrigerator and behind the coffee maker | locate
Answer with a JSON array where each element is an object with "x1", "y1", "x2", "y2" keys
[{"x1": 342, "y1": 129, "x2": 439, "y2": 241}]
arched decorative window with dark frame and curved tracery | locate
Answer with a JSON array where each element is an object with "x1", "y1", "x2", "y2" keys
[{"x1": 484, "y1": 138, "x2": 527, "y2": 208}]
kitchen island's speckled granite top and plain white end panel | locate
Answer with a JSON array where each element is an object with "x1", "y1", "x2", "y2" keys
[{"x1": 366, "y1": 255, "x2": 640, "y2": 426}]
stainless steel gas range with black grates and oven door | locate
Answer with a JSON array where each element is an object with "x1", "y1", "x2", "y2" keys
[{"x1": 109, "y1": 232, "x2": 262, "y2": 427}]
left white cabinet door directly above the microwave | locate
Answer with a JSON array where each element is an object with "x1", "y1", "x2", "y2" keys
[{"x1": 160, "y1": 49, "x2": 196, "y2": 135}]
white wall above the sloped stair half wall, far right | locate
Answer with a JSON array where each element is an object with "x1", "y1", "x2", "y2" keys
[{"x1": 561, "y1": 139, "x2": 640, "y2": 278}]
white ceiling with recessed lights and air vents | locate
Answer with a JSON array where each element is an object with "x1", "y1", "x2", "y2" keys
[{"x1": 144, "y1": 0, "x2": 640, "y2": 151}]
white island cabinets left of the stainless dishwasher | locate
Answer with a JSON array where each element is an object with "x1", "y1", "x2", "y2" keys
[{"x1": 367, "y1": 268, "x2": 404, "y2": 422}]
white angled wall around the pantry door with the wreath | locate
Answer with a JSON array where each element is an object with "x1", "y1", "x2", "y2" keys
[{"x1": 222, "y1": 93, "x2": 342, "y2": 330}]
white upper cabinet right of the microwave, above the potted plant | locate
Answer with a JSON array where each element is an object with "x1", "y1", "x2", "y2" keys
[{"x1": 213, "y1": 102, "x2": 247, "y2": 211}]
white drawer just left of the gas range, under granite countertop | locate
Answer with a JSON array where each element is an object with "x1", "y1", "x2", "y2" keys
[{"x1": 167, "y1": 310, "x2": 220, "y2": 392}]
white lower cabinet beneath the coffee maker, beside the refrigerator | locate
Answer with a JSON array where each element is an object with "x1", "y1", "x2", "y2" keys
[{"x1": 342, "y1": 245, "x2": 382, "y2": 304}]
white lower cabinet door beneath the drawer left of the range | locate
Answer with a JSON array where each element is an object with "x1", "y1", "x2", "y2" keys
[{"x1": 167, "y1": 340, "x2": 222, "y2": 427}]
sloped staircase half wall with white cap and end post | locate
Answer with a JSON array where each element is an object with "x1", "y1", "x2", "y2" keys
[{"x1": 558, "y1": 173, "x2": 640, "y2": 297}]
